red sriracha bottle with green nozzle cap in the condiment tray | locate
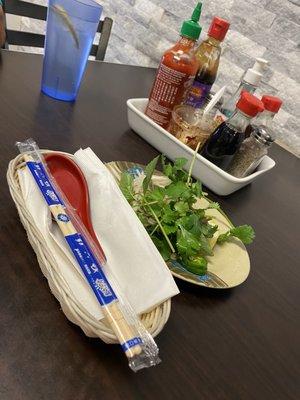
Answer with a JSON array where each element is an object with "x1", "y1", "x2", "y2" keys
[{"x1": 145, "y1": 3, "x2": 202, "y2": 129}]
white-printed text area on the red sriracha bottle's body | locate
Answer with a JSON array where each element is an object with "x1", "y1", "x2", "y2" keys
[{"x1": 145, "y1": 63, "x2": 195, "y2": 128}]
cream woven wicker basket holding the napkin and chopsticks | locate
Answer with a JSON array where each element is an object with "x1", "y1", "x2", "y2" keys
[{"x1": 7, "y1": 151, "x2": 171, "y2": 343}]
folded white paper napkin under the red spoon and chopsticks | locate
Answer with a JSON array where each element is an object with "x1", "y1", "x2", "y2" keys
[{"x1": 19, "y1": 149, "x2": 179, "y2": 319}]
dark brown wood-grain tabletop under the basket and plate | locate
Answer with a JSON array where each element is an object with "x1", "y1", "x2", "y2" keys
[{"x1": 0, "y1": 52, "x2": 300, "y2": 400}]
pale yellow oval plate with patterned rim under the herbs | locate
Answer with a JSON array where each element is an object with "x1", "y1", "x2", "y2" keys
[{"x1": 106, "y1": 161, "x2": 250, "y2": 289}]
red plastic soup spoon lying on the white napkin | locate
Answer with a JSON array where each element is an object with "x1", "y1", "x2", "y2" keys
[{"x1": 44, "y1": 153, "x2": 106, "y2": 260}]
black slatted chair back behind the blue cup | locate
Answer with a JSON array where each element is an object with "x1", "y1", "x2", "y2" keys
[{"x1": 4, "y1": 0, "x2": 113, "y2": 61}]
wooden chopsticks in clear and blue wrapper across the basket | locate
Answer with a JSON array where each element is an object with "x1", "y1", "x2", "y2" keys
[{"x1": 17, "y1": 139, "x2": 160, "y2": 371}]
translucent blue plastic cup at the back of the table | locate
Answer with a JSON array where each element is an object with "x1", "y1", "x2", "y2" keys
[{"x1": 42, "y1": 0, "x2": 102, "y2": 101}]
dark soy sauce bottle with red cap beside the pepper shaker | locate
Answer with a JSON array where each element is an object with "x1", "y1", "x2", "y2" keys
[{"x1": 202, "y1": 91, "x2": 264, "y2": 171}]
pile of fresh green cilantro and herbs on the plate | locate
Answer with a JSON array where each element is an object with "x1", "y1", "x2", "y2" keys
[{"x1": 120, "y1": 156, "x2": 254, "y2": 275}]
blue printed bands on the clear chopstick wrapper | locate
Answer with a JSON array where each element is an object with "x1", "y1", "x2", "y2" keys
[{"x1": 27, "y1": 161, "x2": 117, "y2": 306}]
